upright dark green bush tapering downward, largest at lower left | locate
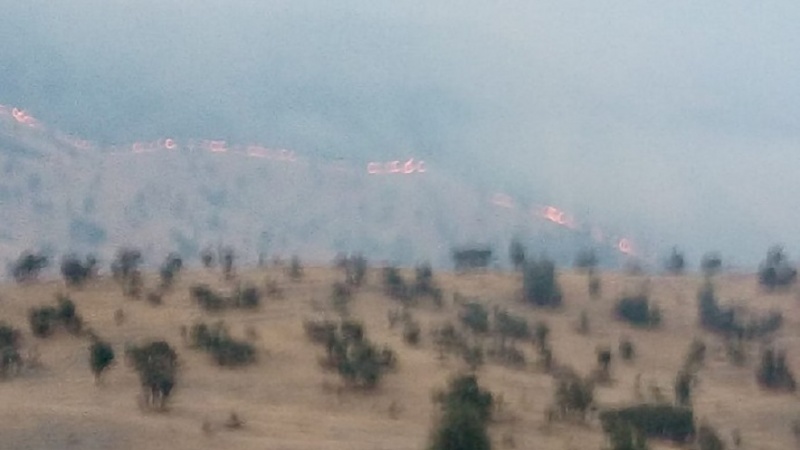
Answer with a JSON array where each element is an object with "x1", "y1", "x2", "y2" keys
[{"x1": 125, "y1": 341, "x2": 178, "y2": 410}]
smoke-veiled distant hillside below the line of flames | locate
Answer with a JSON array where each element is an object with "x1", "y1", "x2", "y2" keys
[{"x1": 0, "y1": 107, "x2": 632, "y2": 265}]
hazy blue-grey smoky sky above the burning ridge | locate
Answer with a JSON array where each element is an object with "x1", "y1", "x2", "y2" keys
[{"x1": 0, "y1": 0, "x2": 800, "y2": 263}]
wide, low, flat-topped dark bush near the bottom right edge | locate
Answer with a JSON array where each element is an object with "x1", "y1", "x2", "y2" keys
[{"x1": 600, "y1": 404, "x2": 695, "y2": 443}]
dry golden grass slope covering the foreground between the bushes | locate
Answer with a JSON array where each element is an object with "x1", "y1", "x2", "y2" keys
[{"x1": 0, "y1": 268, "x2": 800, "y2": 450}]
